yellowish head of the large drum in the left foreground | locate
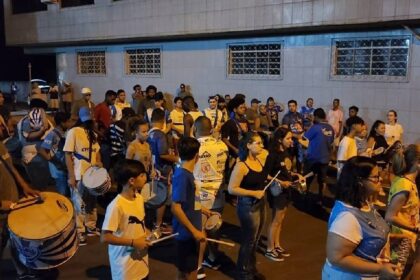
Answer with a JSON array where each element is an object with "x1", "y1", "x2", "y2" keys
[{"x1": 7, "y1": 192, "x2": 73, "y2": 239}]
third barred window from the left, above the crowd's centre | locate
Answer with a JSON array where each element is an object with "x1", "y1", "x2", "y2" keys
[{"x1": 227, "y1": 43, "x2": 282, "y2": 79}]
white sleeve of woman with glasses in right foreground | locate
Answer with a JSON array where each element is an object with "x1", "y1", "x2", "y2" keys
[{"x1": 328, "y1": 201, "x2": 363, "y2": 244}]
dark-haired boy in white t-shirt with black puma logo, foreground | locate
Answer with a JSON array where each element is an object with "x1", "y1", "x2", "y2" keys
[{"x1": 101, "y1": 159, "x2": 150, "y2": 280}]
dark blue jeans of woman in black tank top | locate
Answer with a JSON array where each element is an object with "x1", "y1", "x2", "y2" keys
[{"x1": 236, "y1": 196, "x2": 265, "y2": 280}]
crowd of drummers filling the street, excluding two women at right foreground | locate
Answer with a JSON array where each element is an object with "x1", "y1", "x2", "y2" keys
[{"x1": 0, "y1": 86, "x2": 418, "y2": 279}]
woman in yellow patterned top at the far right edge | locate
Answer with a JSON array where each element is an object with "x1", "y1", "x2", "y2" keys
[{"x1": 385, "y1": 145, "x2": 420, "y2": 279}]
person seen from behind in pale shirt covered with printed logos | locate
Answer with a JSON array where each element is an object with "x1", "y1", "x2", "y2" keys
[{"x1": 194, "y1": 116, "x2": 229, "y2": 270}]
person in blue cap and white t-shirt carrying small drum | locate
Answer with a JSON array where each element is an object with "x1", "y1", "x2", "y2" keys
[{"x1": 63, "y1": 107, "x2": 102, "y2": 245}]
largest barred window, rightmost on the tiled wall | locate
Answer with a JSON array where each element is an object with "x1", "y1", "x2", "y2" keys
[{"x1": 331, "y1": 37, "x2": 410, "y2": 82}]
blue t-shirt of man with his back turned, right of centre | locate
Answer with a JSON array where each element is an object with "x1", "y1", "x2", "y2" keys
[{"x1": 304, "y1": 123, "x2": 334, "y2": 164}]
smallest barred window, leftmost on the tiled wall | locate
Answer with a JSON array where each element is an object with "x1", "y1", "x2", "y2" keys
[{"x1": 77, "y1": 51, "x2": 106, "y2": 75}]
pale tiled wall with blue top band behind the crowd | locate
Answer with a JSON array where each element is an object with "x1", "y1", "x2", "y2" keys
[{"x1": 41, "y1": 30, "x2": 420, "y2": 142}]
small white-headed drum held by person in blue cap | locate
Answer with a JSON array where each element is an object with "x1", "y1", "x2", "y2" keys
[{"x1": 82, "y1": 166, "x2": 111, "y2": 196}]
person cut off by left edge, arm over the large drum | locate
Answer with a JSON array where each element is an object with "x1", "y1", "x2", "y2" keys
[{"x1": 0, "y1": 141, "x2": 38, "y2": 279}]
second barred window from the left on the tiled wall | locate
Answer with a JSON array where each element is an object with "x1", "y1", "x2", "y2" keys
[{"x1": 125, "y1": 48, "x2": 161, "y2": 76}]
